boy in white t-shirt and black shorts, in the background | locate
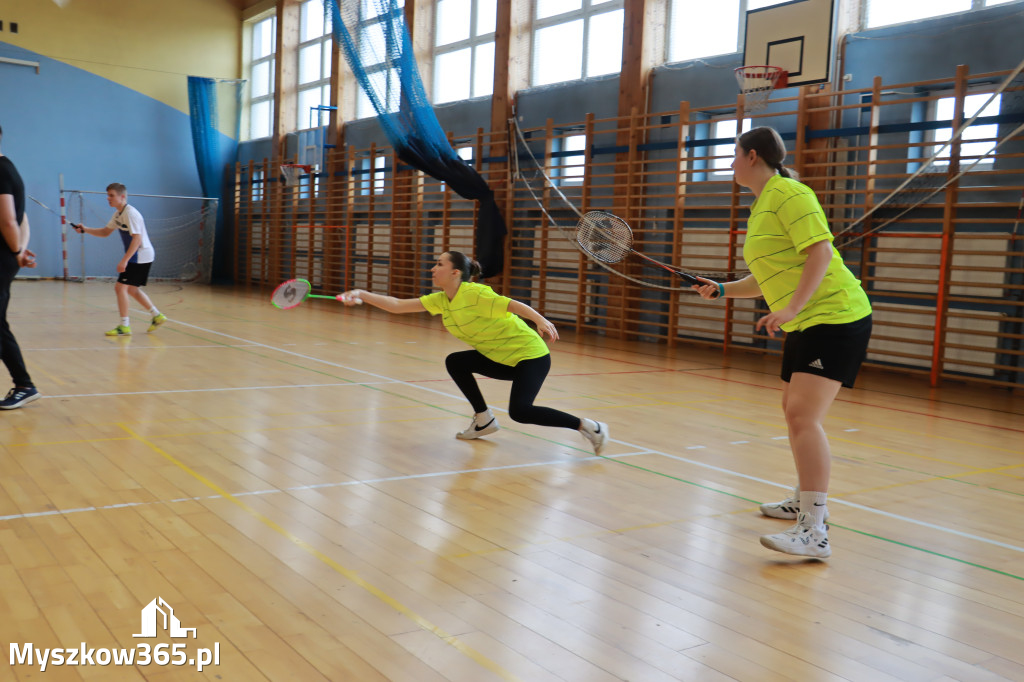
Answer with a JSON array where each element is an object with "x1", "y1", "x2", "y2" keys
[{"x1": 71, "y1": 182, "x2": 167, "y2": 336}]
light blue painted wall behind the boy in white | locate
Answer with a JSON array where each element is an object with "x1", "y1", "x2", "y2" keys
[{"x1": 0, "y1": 42, "x2": 234, "y2": 278}]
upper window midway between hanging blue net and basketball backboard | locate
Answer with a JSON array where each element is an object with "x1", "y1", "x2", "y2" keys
[{"x1": 531, "y1": 0, "x2": 625, "y2": 85}]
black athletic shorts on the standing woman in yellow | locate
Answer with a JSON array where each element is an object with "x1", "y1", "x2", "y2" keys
[{"x1": 781, "y1": 315, "x2": 871, "y2": 388}]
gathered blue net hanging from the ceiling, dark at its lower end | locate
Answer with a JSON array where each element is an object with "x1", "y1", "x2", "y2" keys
[{"x1": 324, "y1": 0, "x2": 506, "y2": 278}]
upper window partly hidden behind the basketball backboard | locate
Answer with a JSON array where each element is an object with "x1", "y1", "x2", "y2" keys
[{"x1": 668, "y1": 0, "x2": 785, "y2": 61}]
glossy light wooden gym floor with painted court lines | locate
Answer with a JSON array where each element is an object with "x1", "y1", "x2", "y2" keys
[{"x1": 6, "y1": 282, "x2": 1024, "y2": 682}]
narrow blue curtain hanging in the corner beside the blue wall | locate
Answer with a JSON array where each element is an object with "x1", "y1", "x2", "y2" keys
[{"x1": 188, "y1": 76, "x2": 242, "y2": 279}]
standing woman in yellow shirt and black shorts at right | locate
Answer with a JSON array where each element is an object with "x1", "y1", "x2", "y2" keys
[{"x1": 694, "y1": 127, "x2": 871, "y2": 558}]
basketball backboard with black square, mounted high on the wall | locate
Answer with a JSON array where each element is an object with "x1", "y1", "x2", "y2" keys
[{"x1": 743, "y1": 0, "x2": 836, "y2": 87}]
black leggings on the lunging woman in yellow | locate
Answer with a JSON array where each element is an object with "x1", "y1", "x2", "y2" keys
[{"x1": 444, "y1": 350, "x2": 580, "y2": 429}]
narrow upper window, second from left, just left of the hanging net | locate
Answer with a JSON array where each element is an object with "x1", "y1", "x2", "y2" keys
[{"x1": 297, "y1": 0, "x2": 334, "y2": 130}]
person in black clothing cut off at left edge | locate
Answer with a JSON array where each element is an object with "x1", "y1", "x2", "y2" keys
[{"x1": 0, "y1": 123, "x2": 39, "y2": 410}]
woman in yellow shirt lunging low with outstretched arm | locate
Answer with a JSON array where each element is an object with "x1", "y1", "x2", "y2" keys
[{"x1": 339, "y1": 251, "x2": 608, "y2": 455}]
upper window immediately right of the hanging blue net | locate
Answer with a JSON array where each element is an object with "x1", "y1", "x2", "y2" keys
[{"x1": 433, "y1": 0, "x2": 498, "y2": 104}]
